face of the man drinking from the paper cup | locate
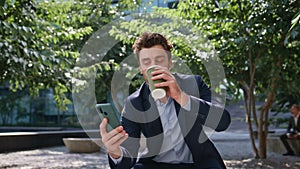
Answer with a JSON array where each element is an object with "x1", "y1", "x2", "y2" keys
[{"x1": 139, "y1": 45, "x2": 172, "y2": 82}]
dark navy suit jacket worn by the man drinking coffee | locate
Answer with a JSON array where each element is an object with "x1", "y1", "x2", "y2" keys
[{"x1": 109, "y1": 74, "x2": 231, "y2": 169}]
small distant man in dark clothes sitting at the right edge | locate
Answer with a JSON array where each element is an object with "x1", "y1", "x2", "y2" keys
[{"x1": 280, "y1": 104, "x2": 300, "y2": 156}]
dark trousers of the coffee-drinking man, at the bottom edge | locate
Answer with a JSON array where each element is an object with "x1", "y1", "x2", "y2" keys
[{"x1": 133, "y1": 160, "x2": 222, "y2": 169}]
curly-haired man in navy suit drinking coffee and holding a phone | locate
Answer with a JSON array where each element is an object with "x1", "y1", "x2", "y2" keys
[{"x1": 100, "y1": 32, "x2": 231, "y2": 169}]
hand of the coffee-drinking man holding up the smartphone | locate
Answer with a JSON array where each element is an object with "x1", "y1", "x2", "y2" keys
[{"x1": 100, "y1": 118, "x2": 128, "y2": 159}]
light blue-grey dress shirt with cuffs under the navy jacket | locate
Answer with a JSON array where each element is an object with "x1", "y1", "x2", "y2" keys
[{"x1": 109, "y1": 97, "x2": 193, "y2": 164}]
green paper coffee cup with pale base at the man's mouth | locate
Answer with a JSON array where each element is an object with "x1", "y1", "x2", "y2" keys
[{"x1": 146, "y1": 65, "x2": 166, "y2": 100}]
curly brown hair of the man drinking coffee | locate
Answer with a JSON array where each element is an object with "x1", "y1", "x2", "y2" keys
[{"x1": 132, "y1": 32, "x2": 173, "y2": 60}]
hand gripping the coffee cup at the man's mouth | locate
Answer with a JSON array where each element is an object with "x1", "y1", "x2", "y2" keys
[{"x1": 152, "y1": 67, "x2": 188, "y2": 106}]
